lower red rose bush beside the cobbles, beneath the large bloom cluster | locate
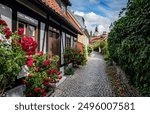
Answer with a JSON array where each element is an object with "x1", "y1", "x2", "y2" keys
[{"x1": 24, "y1": 52, "x2": 62, "y2": 97}]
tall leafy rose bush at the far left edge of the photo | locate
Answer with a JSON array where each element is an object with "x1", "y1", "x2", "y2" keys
[{"x1": 0, "y1": 20, "x2": 26, "y2": 96}]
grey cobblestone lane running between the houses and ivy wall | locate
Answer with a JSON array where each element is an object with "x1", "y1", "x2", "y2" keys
[{"x1": 52, "y1": 52, "x2": 114, "y2": 97}]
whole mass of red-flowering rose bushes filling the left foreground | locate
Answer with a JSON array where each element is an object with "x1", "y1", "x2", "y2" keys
[{"x1": 0, "y1": 20, "x2": 62, "y2": 97}]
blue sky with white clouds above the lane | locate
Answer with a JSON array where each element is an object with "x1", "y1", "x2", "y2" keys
[{"x1": 70, "y1": 0, "x2": 128, "y2": 34}]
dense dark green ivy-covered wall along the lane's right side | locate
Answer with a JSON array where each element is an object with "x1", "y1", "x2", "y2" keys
[{"x1": 108, "y1": 0, "x2": 150, "y2": 96}]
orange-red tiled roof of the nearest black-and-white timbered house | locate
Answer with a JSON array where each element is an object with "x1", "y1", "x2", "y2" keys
[{"x1": 42, "y1": 0, "x2": 82, "y2": 34}]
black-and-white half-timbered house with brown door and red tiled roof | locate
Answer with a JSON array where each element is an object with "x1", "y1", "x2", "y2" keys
[{"x1": 0, "y1": 0, "x2": 82, "y2": 75}]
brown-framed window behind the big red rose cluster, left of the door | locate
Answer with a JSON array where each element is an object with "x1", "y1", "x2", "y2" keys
[{"x1": 18, "y1": 21, "x2": 37, "y2": 39}]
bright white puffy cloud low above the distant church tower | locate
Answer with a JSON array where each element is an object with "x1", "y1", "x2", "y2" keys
[{"x1": 74, "y1": 11, "x2": 111, "y2": 33}]
